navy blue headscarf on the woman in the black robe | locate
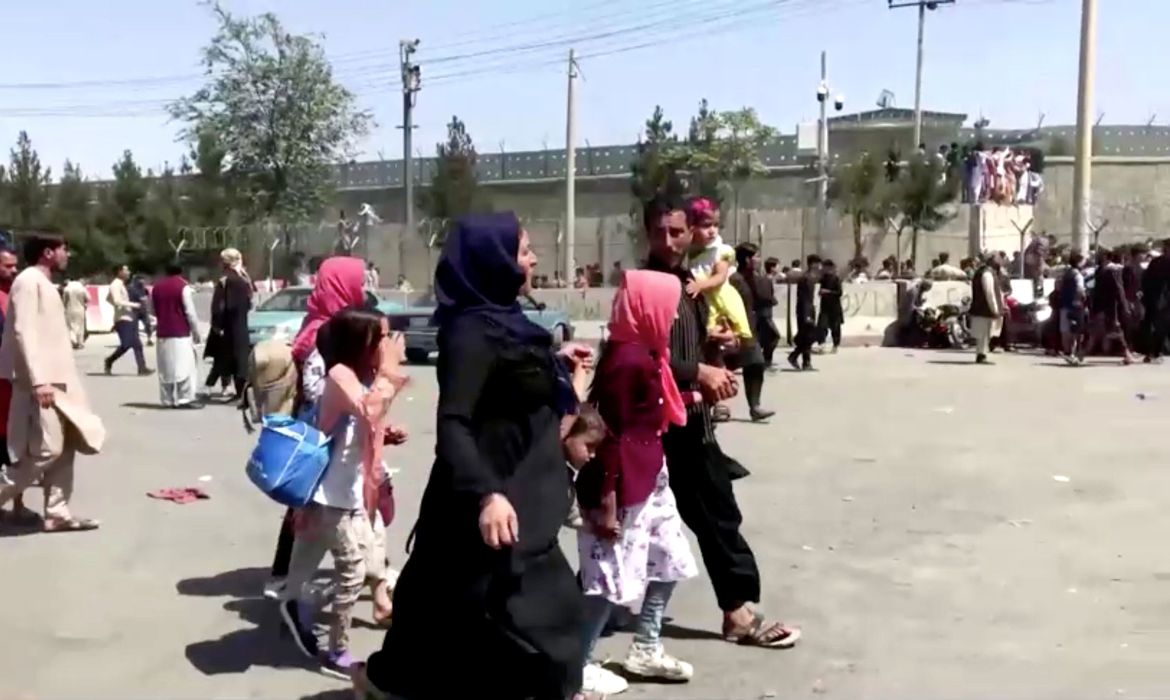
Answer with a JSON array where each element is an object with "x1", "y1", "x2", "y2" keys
[{"x1": 435, "y1": 212, "x2": 577, "y2": 414}]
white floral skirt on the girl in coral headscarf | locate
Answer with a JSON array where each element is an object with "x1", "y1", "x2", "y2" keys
[{"x1": 577, "y1": 465, "x2": 698, "y2": 605}]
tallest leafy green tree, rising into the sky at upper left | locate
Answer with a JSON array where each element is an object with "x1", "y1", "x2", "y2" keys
[{"x1": 170, "y1": 2, "x2": 372, "y2": 222}]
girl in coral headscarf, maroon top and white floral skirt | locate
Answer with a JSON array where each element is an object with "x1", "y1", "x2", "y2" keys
[{"x1": 577, "y1": 270, "x2": 697, "y2": 694}]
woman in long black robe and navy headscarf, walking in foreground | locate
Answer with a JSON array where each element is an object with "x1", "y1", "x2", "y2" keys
[{"x1": 353, "y1": 214, "x2": 590, "y2": 700}]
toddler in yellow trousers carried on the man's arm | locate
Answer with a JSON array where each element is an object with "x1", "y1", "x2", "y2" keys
[{"x1": 687, "y1": 197, "x2": 752, "y2": 339}]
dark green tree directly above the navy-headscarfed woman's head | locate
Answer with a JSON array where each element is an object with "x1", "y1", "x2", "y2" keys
[{"x1": 419, "y1": 117, "x2": 488, "y2": 241}]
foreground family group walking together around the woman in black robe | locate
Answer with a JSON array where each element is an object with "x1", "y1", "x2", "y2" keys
[{"x1": 221, "y1": 199, "x2": 800, "y2": 699}]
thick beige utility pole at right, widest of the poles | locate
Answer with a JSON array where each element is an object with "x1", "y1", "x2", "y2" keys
[{"x1": 1073, "y1": 0, "x2": 1096, "y2": 253}]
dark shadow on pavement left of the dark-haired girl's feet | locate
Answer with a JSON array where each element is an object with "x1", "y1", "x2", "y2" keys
[{"x1": 174, "y1": 567, "x2": 305, "y2": 675}]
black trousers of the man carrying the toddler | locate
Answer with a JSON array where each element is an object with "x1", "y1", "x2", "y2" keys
[{"x1": 662, "y1": 420, "x2": 759, "y2": 612}]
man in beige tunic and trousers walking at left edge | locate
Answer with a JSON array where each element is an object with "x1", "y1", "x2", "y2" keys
[{"x1": 0, "y1": 236, "x2": 105, "y2": 533}]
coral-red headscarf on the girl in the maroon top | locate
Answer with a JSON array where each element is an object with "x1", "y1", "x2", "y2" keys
[{"x1": 610, "y1": 270, "x2": 687, "y2": 427}]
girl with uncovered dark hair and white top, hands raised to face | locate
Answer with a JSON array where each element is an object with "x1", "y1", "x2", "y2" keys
[{"x1": 281, "y1": 309, "x2": 405, "y2": 679}]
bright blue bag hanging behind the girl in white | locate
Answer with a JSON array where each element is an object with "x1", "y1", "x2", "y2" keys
[{"x1": 246, "y1": 412, "x2": 332, "y2": 508}]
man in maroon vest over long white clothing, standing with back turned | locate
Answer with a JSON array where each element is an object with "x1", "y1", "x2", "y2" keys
[{"x1": 151, "y1": 265, "x2": 201, "y2": 409}]
